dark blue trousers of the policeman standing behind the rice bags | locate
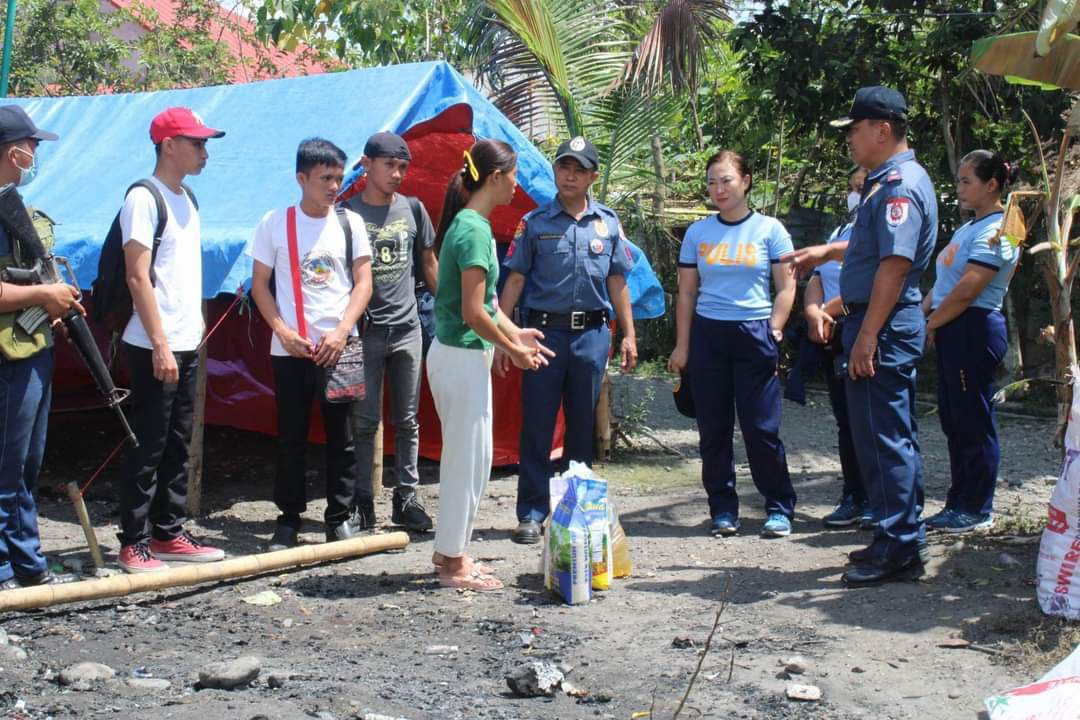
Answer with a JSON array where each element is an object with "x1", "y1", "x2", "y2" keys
[{"x1": 516, "y1": 325, "x2": 611, "y2": 522}]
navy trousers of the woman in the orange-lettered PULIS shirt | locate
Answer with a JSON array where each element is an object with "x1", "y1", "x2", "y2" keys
[{"x1": 689, "y1": 315, "x2": 796, "y2": 518}]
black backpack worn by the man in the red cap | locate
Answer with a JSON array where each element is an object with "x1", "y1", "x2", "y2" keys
[{"x1": 91, "y1": 180, "x2": 199, "y2": 334}]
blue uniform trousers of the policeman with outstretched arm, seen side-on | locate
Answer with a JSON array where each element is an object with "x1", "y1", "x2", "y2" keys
[{"x1": 841, "y1": 303, "x2": 927, "y2": 561}]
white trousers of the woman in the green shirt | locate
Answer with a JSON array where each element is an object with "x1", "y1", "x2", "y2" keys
[{"x1": 428, "y1": 339, "x2": 495, "y2": 557}]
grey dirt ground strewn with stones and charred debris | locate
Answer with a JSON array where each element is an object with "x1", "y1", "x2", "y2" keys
[{"x1": 0, "y1": 378, "x2": 1072, "y2": 720}]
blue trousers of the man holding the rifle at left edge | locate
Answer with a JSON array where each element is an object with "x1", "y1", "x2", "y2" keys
[{"x1": 0, "y1": 349, "x2": 53, "y2": 582}]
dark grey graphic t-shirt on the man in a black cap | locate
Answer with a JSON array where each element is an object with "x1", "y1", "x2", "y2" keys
[{"x1": 345, "y1": 194, "x2": 435, "y2": 325}]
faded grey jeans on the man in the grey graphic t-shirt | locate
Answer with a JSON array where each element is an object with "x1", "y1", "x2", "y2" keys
[{"x1": 352, "y1": 323, "x2": 423, "y2": 501}]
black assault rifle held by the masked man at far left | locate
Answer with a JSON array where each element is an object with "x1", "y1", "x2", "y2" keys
[{"x1": 0, "y1": 182, "x2": 138, "y2": 448}]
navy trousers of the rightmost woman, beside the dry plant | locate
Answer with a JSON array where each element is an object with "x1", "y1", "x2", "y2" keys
[{"x1": 936, "y1": 308, "x2": 1009, "y2": 513}]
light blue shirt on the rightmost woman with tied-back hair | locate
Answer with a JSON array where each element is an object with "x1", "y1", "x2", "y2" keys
[{"x1": 930, "y1": 212, "x2": 1020, "y2": 310}]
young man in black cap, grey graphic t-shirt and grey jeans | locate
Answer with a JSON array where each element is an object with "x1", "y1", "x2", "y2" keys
[{"x1": 345, "y1": 133, "x2": 438, "y2": 532}]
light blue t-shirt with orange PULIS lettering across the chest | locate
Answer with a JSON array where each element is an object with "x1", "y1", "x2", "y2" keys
[{"x1": 678, "y1": 212, "x2": 794, "y2": 321}]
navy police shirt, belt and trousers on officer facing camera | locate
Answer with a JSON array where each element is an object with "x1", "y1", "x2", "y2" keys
[{"x1": 503, "y1": 165, "x2": 633, "y2": 522}]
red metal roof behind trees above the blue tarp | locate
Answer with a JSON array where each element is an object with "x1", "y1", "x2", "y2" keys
[{"x1": 108, "y1": 0, "x2": 336, "y2": 83}]
